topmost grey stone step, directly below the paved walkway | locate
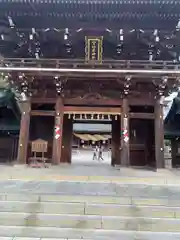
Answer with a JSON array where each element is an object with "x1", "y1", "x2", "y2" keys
[{"x1": 0, "y1": 181, "x2": 180, "y2": 200}]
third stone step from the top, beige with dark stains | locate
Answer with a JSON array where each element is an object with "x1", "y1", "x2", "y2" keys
[{"x1": 0, "y1": 201, "x2": 180, "y2": 219}]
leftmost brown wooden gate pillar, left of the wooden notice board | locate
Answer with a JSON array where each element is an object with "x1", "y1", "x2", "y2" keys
[{"x1": 17, "y1": 99, "x2": 31, "y2": 164}]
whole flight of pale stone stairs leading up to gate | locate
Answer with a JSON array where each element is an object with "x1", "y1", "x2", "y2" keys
[{"x1": 0, "y1": 181, "x2": 180, "y2": 240}]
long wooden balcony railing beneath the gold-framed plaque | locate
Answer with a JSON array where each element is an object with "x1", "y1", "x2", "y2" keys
[{"x1": 0, "y1": 58, "x2": 180, "y2": 70}]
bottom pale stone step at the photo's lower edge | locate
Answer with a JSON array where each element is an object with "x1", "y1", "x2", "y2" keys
[{"x1": 0, "y1": 226, "x2": 180, "y2": 240}]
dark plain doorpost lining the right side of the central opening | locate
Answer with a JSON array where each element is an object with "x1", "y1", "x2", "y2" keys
[{"x1": 111, "y1": 117, "x2": 121, "y2": 166}]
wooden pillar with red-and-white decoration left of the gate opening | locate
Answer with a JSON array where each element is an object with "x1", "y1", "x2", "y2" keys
[{"x1": 52, "y1": 97, "x2": 64, "y2": 164}]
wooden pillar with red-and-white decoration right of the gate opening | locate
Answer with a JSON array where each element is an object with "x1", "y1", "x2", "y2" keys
[{"x1": 121, "y1": 98, "x2": 130, "y2": 167}]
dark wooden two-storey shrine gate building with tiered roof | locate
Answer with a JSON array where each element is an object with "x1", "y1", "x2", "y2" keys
[{"x1": 0, "y1": 0, "x2": 180, "y2": 169}]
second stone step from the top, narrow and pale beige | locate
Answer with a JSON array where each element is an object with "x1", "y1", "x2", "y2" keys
[{"x1": 0, "y1": 193, "x2": 180, "y2": 207}]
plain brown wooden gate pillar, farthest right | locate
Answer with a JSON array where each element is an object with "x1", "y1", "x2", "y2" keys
[{"x1": 154, "y1": 97, "x2": 164, "y2": 169}]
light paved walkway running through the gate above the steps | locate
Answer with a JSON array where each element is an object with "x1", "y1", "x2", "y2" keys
[{"x1": 0, "y1": 150, "x2": 177, "y2": 185}]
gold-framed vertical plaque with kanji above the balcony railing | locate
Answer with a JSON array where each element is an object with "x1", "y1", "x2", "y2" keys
[{"x1": 85, "y1": 36, "x2": 103, "y2": 63}]
